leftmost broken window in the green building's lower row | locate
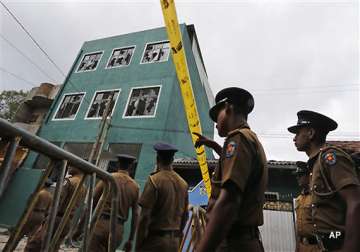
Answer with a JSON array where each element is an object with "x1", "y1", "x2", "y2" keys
[{"x1": 54, "y1": 93, "x2": 85, "y2": 120}]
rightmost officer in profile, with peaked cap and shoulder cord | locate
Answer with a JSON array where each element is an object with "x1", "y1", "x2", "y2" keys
[{"x1": 288, "y1": 110, "x2": 360, "y2": 252}]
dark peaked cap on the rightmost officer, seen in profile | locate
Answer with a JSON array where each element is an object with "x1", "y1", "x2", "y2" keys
[{"x1": 288, "y1": 110, "x2": 337, "y2": 134}]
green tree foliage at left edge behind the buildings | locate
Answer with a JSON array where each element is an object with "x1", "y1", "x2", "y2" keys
[{"x1": 0, "y1": 90, "x2": 28, "y2": 121}]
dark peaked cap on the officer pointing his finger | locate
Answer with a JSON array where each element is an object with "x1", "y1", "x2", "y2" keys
[{"x1": 209, "y1": 87, "x2": 254, "y2": 122}]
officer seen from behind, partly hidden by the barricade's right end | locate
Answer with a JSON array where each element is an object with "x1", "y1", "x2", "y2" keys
[{"x1": 89, "y1": 154, "x2": 139, "y2": 252}]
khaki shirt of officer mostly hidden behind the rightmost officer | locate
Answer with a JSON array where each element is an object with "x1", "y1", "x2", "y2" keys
[{"x1": 295, "y1": 192, "x2": 314, "y2": 237}]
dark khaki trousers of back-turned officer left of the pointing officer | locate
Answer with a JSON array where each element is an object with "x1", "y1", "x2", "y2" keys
[{"x1": 136, "y1": 233, "x2": 180, "y2": 252}]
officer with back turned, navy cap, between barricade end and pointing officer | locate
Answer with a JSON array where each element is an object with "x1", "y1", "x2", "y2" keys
[{"x1": 136, "y1": 143, "x2": 188, "y2": 252}]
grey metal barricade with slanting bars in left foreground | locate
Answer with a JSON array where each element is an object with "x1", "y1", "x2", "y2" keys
[{"x1": 0, "y1": 119, "x2": 119, "y2": 252}]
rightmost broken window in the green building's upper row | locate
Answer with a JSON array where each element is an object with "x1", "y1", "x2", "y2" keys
[{"x1": 141, "y1": 41, "x2": 170, "y2": 64}]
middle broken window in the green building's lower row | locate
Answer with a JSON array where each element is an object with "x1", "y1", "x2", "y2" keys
[{"x1": 86, "y1": 89, "x2": 120, "y2": 119}]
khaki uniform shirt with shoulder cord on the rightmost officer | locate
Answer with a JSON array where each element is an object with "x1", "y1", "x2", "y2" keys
[{"x1": 308, "y1": 148, "x2": 360, "y2": 232}]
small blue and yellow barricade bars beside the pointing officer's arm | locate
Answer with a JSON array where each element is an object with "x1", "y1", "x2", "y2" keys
[{"x1": 179, "y1": 205, "x2": 206, "y2": 252}]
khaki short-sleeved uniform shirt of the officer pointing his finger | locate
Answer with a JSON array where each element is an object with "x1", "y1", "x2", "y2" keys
[{"x1": 208, "y1": 123, "x2": 268, "y2": 228}]
